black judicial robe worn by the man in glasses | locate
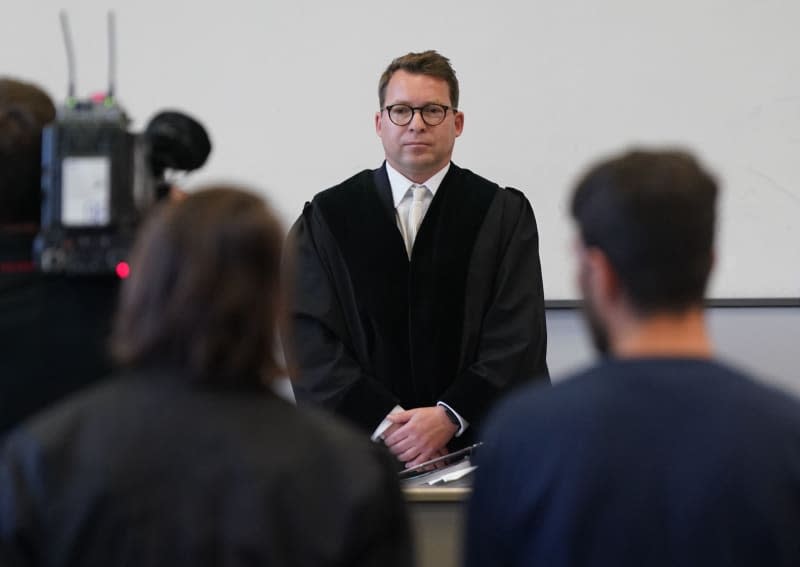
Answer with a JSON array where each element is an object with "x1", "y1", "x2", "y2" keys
[{"x1": 286, "y1": 164, "x2": 547, "y2": 444}]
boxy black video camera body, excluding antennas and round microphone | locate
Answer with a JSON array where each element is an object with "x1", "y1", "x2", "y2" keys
[{"x1": 34, "y1": 97, "x2": 158, "y2": 274}]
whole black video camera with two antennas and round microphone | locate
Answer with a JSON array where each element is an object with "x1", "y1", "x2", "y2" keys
[{"x1": 34, "y1": 12, "x2": 211, "y2": 278}]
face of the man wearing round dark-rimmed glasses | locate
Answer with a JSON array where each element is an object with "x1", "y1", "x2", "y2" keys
[{"x1": 375, "y1": 71, "x2": 464, "y2": 183}]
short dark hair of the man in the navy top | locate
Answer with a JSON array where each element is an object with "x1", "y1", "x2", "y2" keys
[{"x1": 572, "y1": 151, "x2": 717, "y2": 316}]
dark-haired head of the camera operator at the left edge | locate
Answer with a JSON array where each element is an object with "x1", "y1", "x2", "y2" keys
[{"x1": 0, "y1": 78, "x2": 56, "y2": 224}]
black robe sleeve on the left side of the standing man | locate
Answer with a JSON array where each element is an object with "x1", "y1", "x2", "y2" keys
[{"x1": 284, "y1": 204, "x2": 399, "y2": 432}]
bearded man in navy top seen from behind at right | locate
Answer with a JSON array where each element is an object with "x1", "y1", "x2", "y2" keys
[{"x1": 465, "y1": 151, "x2": 800, "y2": 567}]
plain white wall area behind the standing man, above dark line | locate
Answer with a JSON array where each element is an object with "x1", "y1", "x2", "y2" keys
[{"x1": 0, "y1": 0, "x2": 800, "y2": 299}]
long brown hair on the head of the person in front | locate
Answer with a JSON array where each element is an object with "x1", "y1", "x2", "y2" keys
[{"x1": 112, "y1": 187, "x2": 283, "y2": 386}]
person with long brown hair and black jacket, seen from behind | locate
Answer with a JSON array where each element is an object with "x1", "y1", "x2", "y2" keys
[{"x1": 0, "y1": 187, "x2": 412, "y2": 567}]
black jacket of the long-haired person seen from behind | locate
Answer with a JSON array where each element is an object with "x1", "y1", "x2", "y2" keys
[{"x1": 0, "y1": 372, "x2": 412, "y2": 567}]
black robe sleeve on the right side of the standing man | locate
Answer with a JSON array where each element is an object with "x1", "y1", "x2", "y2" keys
[{"x1": 441, "y1": 189, "x2": 549, "y2": 424}]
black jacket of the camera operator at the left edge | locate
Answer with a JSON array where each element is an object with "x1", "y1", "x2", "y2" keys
[{"x1": 0, "y1": 231, "x2": 119, "y2": 437}]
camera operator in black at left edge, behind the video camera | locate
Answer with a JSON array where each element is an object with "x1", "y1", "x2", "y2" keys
[{"x1": 0, "y1": 78, "x2": 118, "y2": 436}]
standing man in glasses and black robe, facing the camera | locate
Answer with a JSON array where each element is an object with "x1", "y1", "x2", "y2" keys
[{"x1": 287, "y1": 51, "x2": 547, "y2": 466}]
